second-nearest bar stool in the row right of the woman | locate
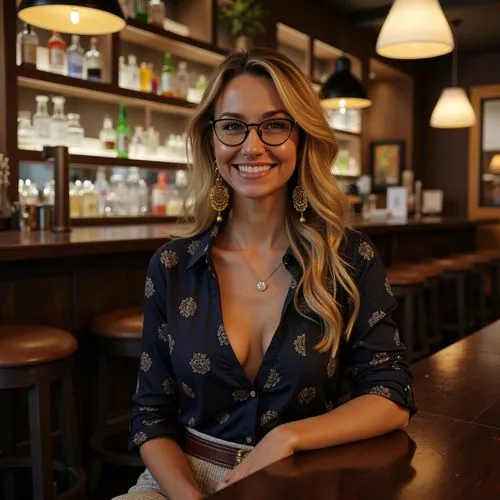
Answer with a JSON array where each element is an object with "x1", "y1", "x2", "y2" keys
[{"x1": 394, "y1": 262, "x2": 443, "y2": 350}]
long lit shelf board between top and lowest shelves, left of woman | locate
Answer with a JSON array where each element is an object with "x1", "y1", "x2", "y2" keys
[{"x1": 17, "y1": 66, "x2": 196, "y2": 116}]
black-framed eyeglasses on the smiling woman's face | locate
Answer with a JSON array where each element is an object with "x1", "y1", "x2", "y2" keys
[{"x1": 210, "y1": 118, "x2": 297, "y2": 146}]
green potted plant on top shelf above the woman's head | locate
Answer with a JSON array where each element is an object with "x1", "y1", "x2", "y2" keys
[{"x1": 219, "y1": 0, "x2": 267, "y2": 50}]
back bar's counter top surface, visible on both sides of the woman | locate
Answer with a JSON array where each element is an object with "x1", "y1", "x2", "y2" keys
[{"x1": 0, "y1": 217, "x2": 497, "y2": 261}]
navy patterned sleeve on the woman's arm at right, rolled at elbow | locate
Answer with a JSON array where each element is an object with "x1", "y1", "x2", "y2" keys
[{"x1": 346, "y1": 235, "x2": 416, "y2": 416}]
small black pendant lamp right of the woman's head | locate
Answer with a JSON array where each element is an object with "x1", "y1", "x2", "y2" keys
[{"x1": 319, "y1": 56, "x2": 372, "y2": 109}]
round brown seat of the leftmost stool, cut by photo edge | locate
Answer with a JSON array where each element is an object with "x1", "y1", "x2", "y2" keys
[{"x1": 0, "y1": 325, "x2": 78, "y2": 368}]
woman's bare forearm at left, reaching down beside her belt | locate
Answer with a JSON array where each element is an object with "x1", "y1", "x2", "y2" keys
[{"x1": 140, "y1": 437, "x2": 203, "y2": 500}]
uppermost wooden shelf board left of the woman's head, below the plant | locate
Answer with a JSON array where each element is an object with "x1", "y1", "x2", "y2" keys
[{"x1": 120, "y1": 19, "x2": 229, "y2": 67}]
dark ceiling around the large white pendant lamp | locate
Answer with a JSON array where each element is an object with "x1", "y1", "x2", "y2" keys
[{"x1": 323, "y1": 0, "x2": 500, "y2": 52}]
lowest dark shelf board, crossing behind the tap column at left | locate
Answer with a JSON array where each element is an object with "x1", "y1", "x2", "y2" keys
[{"x1": 17, "y1": 149, "x2": 186, "y2": 170}]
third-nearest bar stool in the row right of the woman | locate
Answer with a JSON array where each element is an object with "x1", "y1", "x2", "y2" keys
[{"x1": 425, "y1": 257, "x2": 474, "y2": 338}]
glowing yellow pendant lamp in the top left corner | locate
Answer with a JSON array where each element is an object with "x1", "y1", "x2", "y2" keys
[{"x1": 17, "y1": 0, "x2": 125, "y2": 35}]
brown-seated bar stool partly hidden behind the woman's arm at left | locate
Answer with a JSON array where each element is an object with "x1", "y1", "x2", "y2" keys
[{"x1": 89, "y1": 308, "x2": 143, "y2": 491}]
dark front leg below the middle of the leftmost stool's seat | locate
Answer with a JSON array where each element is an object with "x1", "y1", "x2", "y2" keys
[{"x1": 28, "y1": 380, "x2": 55, "y2": 500}]
